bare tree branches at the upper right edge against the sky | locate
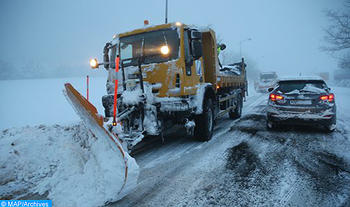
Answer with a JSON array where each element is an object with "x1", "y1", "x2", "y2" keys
[{"x1": 323, "y1": 0, "x2": 350, "y2": 70}]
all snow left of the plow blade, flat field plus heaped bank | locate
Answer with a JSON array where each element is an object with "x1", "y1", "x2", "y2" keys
[{"x1": 0, "y1": 78, "x2": 138, "y2": 206}]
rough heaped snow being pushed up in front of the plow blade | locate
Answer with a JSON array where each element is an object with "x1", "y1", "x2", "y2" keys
[{"x1": 0, "y1": 125, "x2": 138, "y2": 207}]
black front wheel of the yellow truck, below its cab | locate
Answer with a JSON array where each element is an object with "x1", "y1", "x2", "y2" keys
[{"x1": 194, "y1": 98, "x2": 214, "y2": 141}]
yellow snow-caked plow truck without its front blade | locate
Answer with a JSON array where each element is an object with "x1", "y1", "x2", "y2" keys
[{"x1": 66, "y1": 22, "x2": 247, "y2": 150}]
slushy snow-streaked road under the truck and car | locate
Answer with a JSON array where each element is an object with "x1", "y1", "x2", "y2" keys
[{"x1": 107, "y1": 88, "x2": 350, "y2": 206}]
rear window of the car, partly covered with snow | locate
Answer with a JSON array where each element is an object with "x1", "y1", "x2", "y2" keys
[{"x1": 278, "y1": 80, "x2": 327, "y2": 93}]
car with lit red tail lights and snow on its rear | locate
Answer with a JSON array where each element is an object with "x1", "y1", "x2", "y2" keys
[{"x1": 267, "y1": 77, "x2": 336, "y2": 132}]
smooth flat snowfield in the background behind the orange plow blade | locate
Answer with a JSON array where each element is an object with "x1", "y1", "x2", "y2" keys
[{"x1": 0, "y1": 77, "x2": 106, "y2": 130}]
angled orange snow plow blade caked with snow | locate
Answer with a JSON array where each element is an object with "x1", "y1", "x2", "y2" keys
[{"x1": 64, "y1": 83, "x2": 139, "y2": 200}]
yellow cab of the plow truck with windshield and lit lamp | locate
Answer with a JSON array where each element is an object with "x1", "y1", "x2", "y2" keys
[{"x1": 106, "y1": 23, "x2": 217, "y2": 97}]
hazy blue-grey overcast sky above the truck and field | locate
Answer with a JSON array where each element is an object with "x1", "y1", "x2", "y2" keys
[{"x1": 0, "y1": 0, "x2": 342, "y2": 75}]
